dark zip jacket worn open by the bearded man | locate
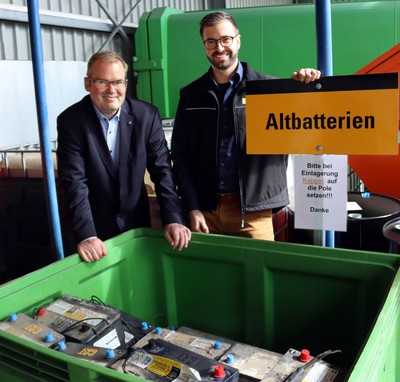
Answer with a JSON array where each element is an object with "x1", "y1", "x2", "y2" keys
[{"x1": 172, "y1": 62, "x2": 289, "y2": 213}]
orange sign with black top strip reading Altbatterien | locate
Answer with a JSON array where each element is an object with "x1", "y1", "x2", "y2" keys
[{"x1": 246, "y1": 73, "x2": 399, "y2": 154}]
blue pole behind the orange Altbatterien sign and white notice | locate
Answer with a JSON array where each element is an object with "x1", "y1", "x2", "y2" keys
[{"x1": 315, "y1": 0, "x2": 335, "y2": 248}]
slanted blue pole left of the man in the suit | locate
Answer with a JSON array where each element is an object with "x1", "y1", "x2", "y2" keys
[{"x1": 27, "y1": 0, "x2": 64, "y2": 260}]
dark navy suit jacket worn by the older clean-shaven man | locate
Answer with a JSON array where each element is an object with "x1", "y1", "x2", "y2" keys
[{"x1": 57, "y1": 96, "x2": 182, "y2": 242}]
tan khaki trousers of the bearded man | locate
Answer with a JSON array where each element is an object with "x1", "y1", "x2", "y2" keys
[{"x1": 203, "y1": 194, "x2": 274, "y2": 241}]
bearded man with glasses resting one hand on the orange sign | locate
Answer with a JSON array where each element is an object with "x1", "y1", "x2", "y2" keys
[{"x1": 172, "y1": 12, "x2": 320, "y2": 240}]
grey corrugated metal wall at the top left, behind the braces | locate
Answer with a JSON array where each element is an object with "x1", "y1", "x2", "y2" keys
[{"x1": 0, "y1": 0, "x2": 292, "y2": 61}]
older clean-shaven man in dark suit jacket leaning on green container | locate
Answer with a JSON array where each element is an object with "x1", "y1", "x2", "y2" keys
[{"x1": 57, "y1": 52, "x2": 191, "y2": 262}]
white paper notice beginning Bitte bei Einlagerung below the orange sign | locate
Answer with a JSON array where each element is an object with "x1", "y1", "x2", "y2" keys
[{"x1": 293, "y1": 155, "x2": 347, "y2": 231}]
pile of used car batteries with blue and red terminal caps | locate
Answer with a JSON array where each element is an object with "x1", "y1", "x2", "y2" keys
[{"x1": 0, "y1": 296, "x2": 338, "y2": 382}]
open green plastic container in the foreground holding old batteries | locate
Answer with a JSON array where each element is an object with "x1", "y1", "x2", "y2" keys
[{"x1": 0, "y1": 229, "x2": 400, "y2": 382}]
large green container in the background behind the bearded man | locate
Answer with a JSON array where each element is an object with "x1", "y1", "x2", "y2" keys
[{"x1": 133, "y1": 0, "x2": 400, "y2": 117}]
